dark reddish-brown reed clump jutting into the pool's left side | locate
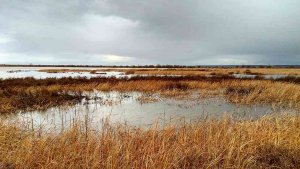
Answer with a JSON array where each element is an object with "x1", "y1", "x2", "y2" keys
[{"x1": 0, "y1": 87, "x2": 83, "y2": 113}]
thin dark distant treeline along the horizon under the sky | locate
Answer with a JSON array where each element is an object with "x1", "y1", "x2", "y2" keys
[{"x1": 0, "y1": 64, "x2": 300, "y2": 68}]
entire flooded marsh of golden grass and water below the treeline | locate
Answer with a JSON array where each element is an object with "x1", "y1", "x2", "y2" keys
[{"x1": 0, "y1": 68, "x2": 300, "y2": 168}]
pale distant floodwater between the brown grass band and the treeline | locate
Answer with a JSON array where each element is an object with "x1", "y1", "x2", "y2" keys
[{"x1": 0, "y1": 67, "x2": 300, "y2": 79}]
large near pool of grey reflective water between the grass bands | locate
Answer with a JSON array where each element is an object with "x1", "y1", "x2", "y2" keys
[{"x1": 2, "y1": 92, "x2": 297, "y2": 131}]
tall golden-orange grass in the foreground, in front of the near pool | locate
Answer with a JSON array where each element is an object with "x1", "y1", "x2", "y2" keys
[{"x1": 0, "y1": 115, "x2": 300, "y2": 168}]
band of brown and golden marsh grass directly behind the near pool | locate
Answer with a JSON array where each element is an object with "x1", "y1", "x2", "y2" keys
[{"x1": 0, "y1": 76, "x2": 300, "y2": 113}]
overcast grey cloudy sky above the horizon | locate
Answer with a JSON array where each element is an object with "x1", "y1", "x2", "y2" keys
[{"x1": 0, "y1": 0, "x2": 300, "y2": 65}]
